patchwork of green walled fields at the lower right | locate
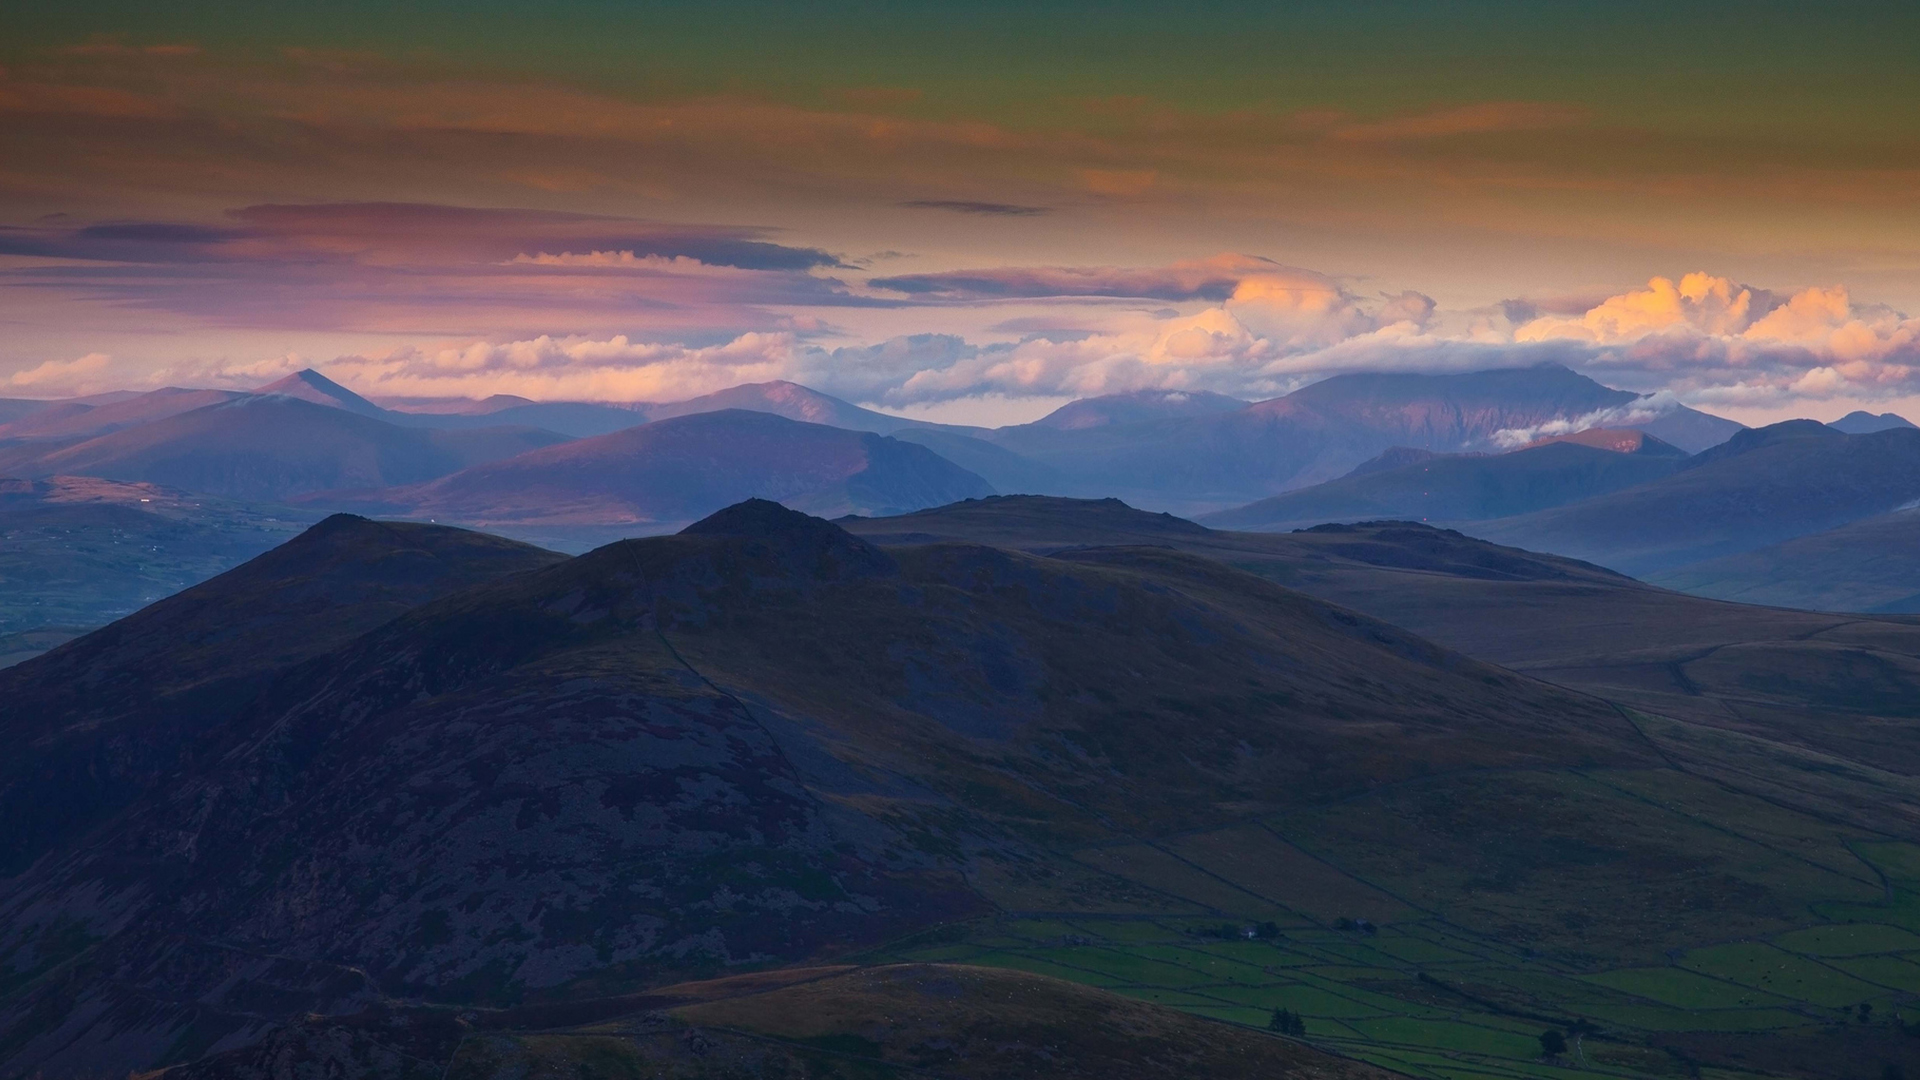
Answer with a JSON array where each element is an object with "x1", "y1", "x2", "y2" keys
[{"x1": 874, "y1": 773, "x2": 1920, "y2": 1080}]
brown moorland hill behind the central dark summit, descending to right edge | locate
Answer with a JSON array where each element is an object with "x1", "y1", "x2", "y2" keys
[{"x1": 845, "y1": 498, "x2": 1920, "y2": 822}]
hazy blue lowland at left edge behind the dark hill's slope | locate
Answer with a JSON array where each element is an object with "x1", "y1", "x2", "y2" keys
[{"x1": 0, "y1": 477, "x2": 313, "y2": 663}]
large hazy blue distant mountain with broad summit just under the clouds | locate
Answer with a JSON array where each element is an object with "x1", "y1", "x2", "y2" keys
[{"x1": 983, "y1": 365, "x2": 1740, "y2": 513}]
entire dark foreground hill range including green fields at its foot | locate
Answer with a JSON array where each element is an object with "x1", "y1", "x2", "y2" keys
[{"x1": 0, "y1": 499, "x2": 1920, "y2": 1080}]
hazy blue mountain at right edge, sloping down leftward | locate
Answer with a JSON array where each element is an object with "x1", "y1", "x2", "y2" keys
[{"x1": 1471, "y1": 421, "x2": 1920, "y2": 575}]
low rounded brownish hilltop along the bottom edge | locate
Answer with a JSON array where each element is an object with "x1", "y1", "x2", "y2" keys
[{"x1": 167, "y1": 965, "x2": 1390, "y2": 1080}]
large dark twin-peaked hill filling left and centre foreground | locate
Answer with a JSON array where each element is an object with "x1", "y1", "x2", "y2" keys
[{"x1": 0, "y1": 502, "x2": 1658, "y2": 1076}]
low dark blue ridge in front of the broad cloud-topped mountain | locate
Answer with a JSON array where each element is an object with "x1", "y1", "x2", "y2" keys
[{"x1": 1200, "y1": 432, "x2": 1686, "y2": 528}]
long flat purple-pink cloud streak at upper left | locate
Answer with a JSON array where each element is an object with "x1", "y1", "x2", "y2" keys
[{"x1": 0, "y1": 204, "x2": 871, "y2": 334}]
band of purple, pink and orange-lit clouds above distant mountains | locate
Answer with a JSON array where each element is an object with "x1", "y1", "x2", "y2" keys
[{"x1": 15, "y1": 203, "x2": 1920, "y2": 418}]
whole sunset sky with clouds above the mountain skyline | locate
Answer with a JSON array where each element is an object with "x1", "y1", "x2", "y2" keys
[{"x1": 0, "y1": 0, "x2": 1920, "y2": 423}]
